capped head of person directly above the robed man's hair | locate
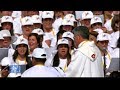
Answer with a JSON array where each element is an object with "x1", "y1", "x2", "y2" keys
[{"x1": 81, "y1": 11, "x2": 93, "y2": 29}]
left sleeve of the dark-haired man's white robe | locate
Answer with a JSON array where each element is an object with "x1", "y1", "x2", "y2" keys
[{"x1": 66, "y1": 52, "x2": 87, "y2": 77}]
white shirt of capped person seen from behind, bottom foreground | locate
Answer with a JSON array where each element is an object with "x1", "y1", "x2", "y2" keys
[{"x1": 21, "y1": 65, "x2": 63, "y2": 77}]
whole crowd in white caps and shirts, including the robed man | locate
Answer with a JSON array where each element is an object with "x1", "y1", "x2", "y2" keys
[{"x1": 0, "y1": 11, "x2": 120, "y2": 78}]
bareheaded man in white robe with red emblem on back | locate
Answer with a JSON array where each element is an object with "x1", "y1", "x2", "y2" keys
[{"x1": 66, "y1": 26, "x2": 104, "y2": 77}]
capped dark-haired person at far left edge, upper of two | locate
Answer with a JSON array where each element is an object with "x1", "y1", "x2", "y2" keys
[{"x1": 1, "y1": 16, "x2": 14, "y2": 36}]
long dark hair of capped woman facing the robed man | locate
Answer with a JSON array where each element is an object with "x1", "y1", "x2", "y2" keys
[{"x1": 53, "y1": 46, "x2": 71, "y2": 67}]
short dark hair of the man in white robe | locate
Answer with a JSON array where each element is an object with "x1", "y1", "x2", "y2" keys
[{"x1": 72, "y1": 26, "x2": 89, "y2": 40}]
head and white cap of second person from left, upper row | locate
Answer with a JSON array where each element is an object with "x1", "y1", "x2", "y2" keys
[{"x1": 20, "y1": 16, "x2": 33, "y2": 39}]
